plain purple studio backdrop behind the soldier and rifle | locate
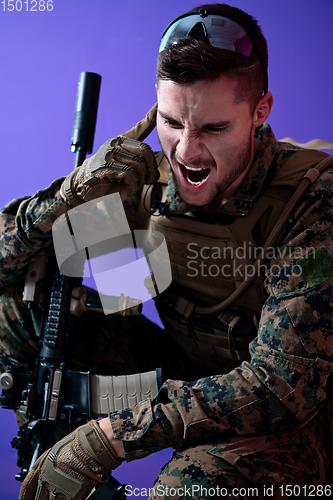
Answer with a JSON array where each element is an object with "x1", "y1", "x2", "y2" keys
[{"x1": 0, "y1": 0, "x2": 333, "y2": 500}]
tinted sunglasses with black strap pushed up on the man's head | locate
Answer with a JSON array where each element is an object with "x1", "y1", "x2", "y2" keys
[{"x1": 159, "y1": 9, "x2": 268, "y2": 93}]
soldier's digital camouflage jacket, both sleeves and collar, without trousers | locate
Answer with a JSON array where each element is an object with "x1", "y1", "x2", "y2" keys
[{"x1": 0, "y1": 125, "x2": 333, "y2": 476}]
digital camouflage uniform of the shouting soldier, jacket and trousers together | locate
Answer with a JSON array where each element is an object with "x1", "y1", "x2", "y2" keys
[{"x1": 0, "y1": 125, "x2": 333, "y2": 498}]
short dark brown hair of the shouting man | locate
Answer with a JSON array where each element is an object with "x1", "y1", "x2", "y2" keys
[{"x1": 156, "y1": 3, "x2": 268, "y2": 110}]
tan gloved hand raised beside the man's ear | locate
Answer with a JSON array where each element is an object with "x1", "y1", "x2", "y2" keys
[{"x1": 61, "y1": 104, "x2": 159, "y2": 207}]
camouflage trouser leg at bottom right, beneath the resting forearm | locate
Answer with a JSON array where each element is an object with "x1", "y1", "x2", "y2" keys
[{"x1": 149, "y1": 428, "x2": 332, "y2": 500}]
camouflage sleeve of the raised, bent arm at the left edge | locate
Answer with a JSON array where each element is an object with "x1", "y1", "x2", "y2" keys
[{"x1": 0, "y1": 178, "x2": 69, "y2": 287}]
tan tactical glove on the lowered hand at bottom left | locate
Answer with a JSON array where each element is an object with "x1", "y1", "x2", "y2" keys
[{"x1": 19, "y1": 420, "x2": 122, "y2": 500}]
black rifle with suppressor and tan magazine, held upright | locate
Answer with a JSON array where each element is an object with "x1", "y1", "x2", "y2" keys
[{"x1": 0, "y1": 72, "x2": 162, "y2": 500}]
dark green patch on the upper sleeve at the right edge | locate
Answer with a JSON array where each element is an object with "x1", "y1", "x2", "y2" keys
[{"x1": 296, "y1": 247, "x2": 333, "y2": 286}]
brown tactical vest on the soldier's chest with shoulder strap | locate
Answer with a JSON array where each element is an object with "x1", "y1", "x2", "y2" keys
[{"x1": 141, "y1": 150, "x2": 332, "y2": 375}]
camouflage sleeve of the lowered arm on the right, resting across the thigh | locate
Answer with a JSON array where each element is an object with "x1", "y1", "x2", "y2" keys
[{"x1": 110, "y1": 165, "x2": 333, "y2": 460}]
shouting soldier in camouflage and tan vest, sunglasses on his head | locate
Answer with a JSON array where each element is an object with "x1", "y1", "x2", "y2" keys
[{"x1": 1, "y1": 4, "x2": 333, "y2": 500}]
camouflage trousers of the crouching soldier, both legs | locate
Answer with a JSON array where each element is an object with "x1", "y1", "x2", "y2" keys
[{"x1": 0, "y1": 282, "x2": 329, "y2": 499}]
